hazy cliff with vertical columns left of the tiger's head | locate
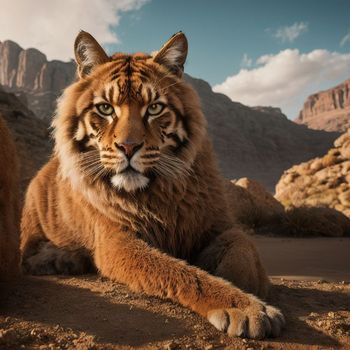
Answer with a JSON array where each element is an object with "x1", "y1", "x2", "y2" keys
[{"x1": 0, "y1": 40, "x2": 75, "y2": 121}]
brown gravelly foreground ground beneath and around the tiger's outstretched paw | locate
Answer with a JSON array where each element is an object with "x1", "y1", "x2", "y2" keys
[{"x1": 0, "y1": 275, "x2": 350, "y2": 350}]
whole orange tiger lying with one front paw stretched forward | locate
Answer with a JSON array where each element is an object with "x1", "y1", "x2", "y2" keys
[{"x1": 21, "y1": 31, "x2": 285, "y2": 339}]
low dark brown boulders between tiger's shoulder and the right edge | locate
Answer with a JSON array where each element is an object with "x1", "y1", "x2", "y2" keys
[{"x1": 226, "y1": 178, "x2": 350, "y2": 237}]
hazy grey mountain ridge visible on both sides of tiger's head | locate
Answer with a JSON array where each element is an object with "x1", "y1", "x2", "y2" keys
[{"x1": 0, "y1": 41, "x2": 339, "y2": 191}]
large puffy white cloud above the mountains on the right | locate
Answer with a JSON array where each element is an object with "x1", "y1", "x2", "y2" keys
[{"x1": 213, "y1": 49, "x2": 350, "y2": 117}]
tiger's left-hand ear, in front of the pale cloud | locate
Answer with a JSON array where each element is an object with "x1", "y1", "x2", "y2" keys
[{"x1": 74, "y1": 30, "x2": 110, "y2": 78}]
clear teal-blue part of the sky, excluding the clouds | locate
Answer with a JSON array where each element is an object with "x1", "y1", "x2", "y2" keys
[{"x1": 109, "y1": 0, "x2": 350, "y2": 84}]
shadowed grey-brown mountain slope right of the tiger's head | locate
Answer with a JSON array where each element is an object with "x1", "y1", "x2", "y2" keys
[{"x1": 186, "y1": 76, "x2": 339, "y2": 191}]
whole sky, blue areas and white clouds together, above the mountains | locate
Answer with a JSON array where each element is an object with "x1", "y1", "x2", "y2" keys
[{"x1": 0, "y1": 0, "x2": 350, "y2": 118}]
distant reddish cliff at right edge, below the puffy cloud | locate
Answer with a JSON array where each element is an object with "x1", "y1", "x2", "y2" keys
[{"x1": 295, "y1": 79, "x2": 350, "y2": 132}]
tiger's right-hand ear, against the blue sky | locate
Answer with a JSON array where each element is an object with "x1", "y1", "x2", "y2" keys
[{"x1": 153, "y1": 32, "x2": 188, "y2": 76}]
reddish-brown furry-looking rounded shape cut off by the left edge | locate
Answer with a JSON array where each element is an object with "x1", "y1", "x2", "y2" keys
[{"x1": 0, "y1": 114, "x2": 20, "y2": 281}]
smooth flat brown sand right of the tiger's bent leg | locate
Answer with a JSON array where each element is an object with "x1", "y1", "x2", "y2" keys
[{"x1": 253, "y1": 236, "x2": 350, "y2": 282}]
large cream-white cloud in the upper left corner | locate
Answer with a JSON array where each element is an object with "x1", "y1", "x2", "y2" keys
[{"x1": 0, "y1": 0, "x2": 148, "y2": 60}]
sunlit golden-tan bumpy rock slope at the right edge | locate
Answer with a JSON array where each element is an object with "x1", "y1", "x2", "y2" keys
[{"x1": 276, "y1": 131, "x2": 350, "y2": 217}]
